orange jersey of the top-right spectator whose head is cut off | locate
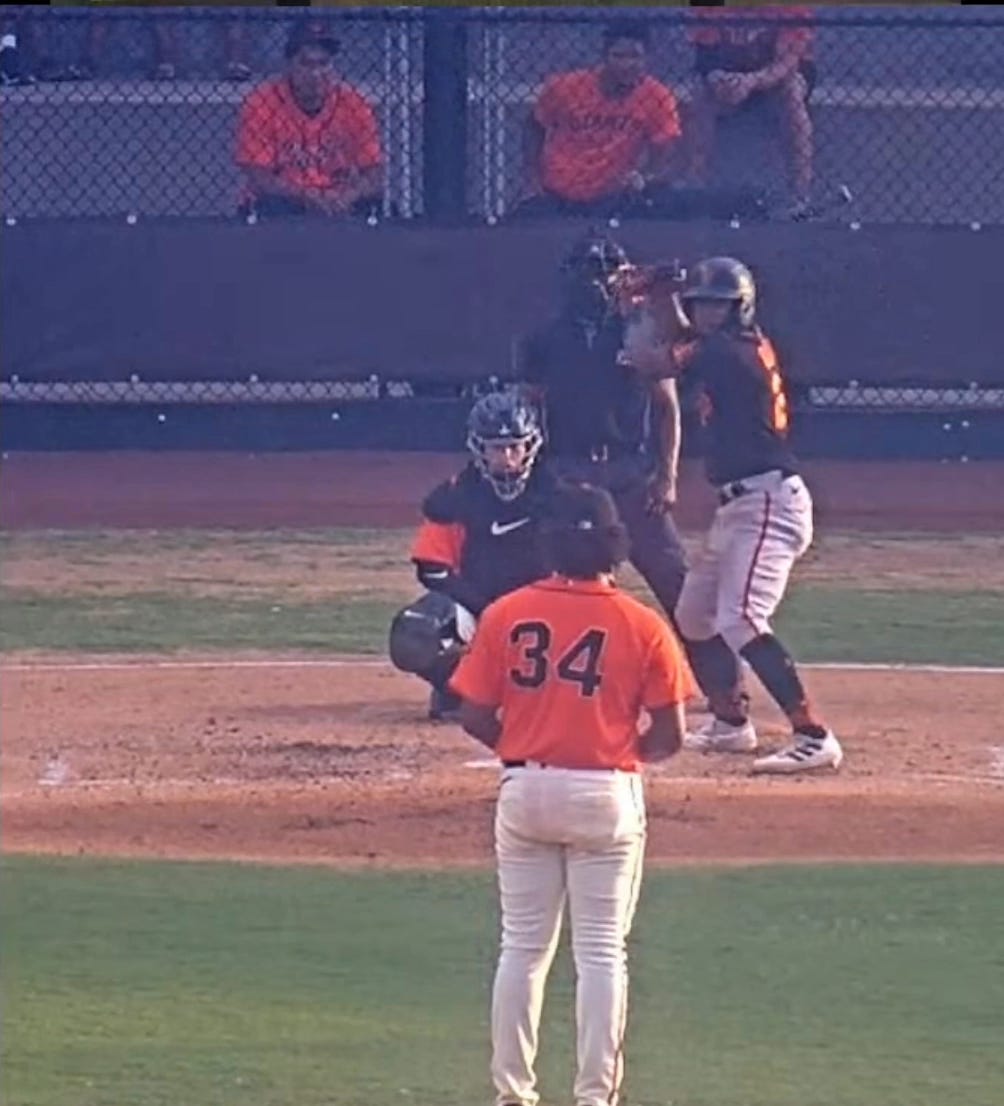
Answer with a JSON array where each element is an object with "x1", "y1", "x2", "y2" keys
[{"x1": 690, "y1": 4, "x2": 813, "y2": 73}]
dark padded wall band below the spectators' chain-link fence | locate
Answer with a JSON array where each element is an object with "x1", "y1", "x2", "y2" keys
[{"x1": 0, "y1": 221, "x2": 1004, "y2": 386}]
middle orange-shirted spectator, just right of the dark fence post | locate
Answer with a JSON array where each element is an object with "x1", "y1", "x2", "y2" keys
[{"x1": 517, "y1": 21, "x2": 680, "y2": 216}]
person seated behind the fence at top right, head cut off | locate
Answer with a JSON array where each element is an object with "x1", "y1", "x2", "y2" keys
[{"x1": 690, "y1": 4, "x2": 816, "y2": 218}]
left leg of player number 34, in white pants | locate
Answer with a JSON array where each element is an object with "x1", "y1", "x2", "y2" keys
[{"x1": 491, "y1": 805, "x2": 565, "y2": 1106}]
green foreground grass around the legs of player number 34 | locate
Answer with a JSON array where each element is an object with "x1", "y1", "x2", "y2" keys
[{"x1": 2, "y1": 858, "x2": 1004, "y2": 1106}]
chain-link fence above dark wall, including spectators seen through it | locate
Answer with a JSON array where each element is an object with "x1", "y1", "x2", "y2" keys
[{"x1": 0, "y1": 4, "x2": 1004, "y2": 226}]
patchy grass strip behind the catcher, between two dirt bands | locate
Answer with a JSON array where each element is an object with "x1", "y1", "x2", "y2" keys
[{"x1": 0, "y1": 529, "x2": 1004, "y2": 665}]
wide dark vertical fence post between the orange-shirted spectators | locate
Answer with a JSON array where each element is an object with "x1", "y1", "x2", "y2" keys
[{"x1": 422, "y1": 8, "x2": 468, "y2": 220}]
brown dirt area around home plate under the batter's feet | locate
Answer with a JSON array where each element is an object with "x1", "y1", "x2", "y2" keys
[{"x1": 2, "y1": 658, "x2": 1004, "y2": 866}]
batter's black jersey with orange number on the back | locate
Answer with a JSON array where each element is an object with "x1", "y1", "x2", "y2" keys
[{"x1": 674, "y1": 327, "x2": 798, "y2": 484}]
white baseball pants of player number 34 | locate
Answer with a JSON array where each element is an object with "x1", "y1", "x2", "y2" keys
[{"x1": 491, "y1": 763, "x2": 646, "y2": 1106}]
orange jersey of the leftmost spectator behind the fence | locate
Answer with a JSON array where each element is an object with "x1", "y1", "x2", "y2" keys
[{"x1": 237, "y1": 77, "x2": 383, "y2": 191}]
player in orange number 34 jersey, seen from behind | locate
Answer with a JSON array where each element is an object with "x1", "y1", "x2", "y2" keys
[{"x1": 451, "y1": 486, "x2": 693, "y2": 1106}]
